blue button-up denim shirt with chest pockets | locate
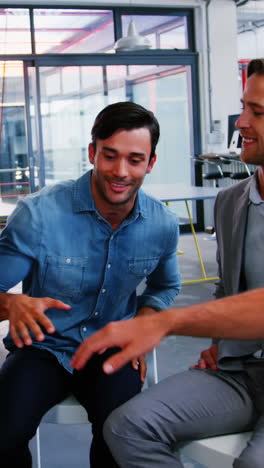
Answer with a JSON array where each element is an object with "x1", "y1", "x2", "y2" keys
[{"x1": 0, "y1": 171, "x2": 180, "y2": 372}]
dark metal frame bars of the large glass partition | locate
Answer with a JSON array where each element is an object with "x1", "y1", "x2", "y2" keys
[{"x1": 0, "y1": 3, "x2": 204, "y2": 229}]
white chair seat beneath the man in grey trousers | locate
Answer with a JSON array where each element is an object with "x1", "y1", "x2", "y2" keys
[{"x1": 181, "y1": 432, "x2": 252, "y2": 468}]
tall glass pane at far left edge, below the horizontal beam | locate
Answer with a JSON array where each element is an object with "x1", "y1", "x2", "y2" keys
[{"x1": 0, "y1": 62, "x2": 30, "y2": 226}]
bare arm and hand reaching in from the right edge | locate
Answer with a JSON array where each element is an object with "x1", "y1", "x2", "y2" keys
[{"x1": 72, "y1": 288, "x2": 264, "y2": 373}]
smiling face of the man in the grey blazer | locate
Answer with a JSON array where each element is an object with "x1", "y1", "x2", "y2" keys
[{"x1": 236, "y1": 73, "x2": 264, "y2": 165}]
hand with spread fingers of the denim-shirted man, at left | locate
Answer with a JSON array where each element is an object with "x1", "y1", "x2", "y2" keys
[{"x1": 8, "y1": 294, "x2": 70, "y2": 348}]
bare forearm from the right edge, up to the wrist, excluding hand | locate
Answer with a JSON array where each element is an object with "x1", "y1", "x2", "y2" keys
[{"x1": 164, "y1": 288, "x2": 264, "y2": 339}]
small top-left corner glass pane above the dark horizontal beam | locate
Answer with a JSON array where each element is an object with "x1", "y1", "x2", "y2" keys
[{"x1": 0, "y1": 8, "x2": 31, "y2": 55}]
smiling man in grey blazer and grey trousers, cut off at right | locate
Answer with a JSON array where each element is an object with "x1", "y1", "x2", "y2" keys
[{"x1": 82, "y1": 59, "x2": 264, "y2": 468}]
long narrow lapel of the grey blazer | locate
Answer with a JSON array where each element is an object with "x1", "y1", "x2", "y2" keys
[{"x1": 231, "y1": 180, "x2": 250, "y2": 294}]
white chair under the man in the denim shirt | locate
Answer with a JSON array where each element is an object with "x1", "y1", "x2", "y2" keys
[{"x1": 36, "y1": 349, "x2": 158, "y2": 468}]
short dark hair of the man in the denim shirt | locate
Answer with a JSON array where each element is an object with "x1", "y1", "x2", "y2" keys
[{"x1": 91, "y1": 101, "x2": 160, "y2": 159}]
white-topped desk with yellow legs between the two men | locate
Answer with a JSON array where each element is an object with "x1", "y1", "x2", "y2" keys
[{"x1": 143, "y1": 184, "x2": 221, "y2": 284}]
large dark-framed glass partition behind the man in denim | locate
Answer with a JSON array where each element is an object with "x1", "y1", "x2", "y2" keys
[{"x1": 0, "y1": 4, "x2": 200, "y2": 227}]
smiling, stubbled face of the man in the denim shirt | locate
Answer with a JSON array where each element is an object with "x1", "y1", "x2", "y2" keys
[{"x1": 89, "y1": 127, "x2": 156, "y2": 216}]
